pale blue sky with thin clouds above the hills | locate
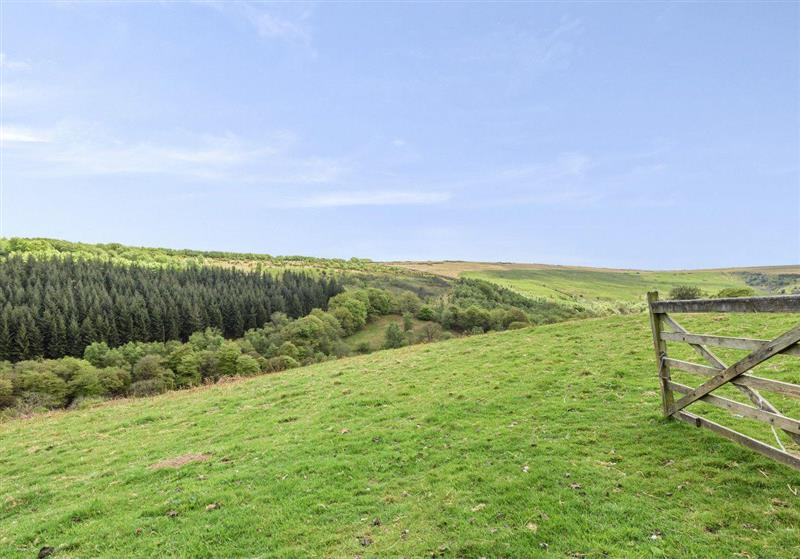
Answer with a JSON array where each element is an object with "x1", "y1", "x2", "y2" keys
[{"x1": 0, "y1": 1, "x2": 800, "y2": 268}]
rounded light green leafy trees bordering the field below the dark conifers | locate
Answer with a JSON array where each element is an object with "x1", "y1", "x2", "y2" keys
[{"x1": 0, "y1": 288, "x2": 412, "y2": 417}]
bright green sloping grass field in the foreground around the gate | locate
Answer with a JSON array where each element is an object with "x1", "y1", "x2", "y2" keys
[{"x1": 0, "y1": 315, "x2": 800, "y2": 559}]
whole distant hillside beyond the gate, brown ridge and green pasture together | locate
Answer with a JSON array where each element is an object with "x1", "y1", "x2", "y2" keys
[{"x1": 395, "y1": 261, "x2": 800, "y2": 306}]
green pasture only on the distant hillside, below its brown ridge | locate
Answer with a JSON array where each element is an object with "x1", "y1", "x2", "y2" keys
[{"x1": 461, "y1": 268, "x2": 760, "y2": 303}]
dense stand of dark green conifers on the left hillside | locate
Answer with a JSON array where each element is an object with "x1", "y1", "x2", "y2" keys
[{"x1": 0, "y1": 256, "x2": 342, "y2": 362}]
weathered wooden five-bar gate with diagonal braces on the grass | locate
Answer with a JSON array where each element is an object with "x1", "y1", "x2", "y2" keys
[{"x1": 647, "y1": 292, "x2": 800, "y2": 469}]
